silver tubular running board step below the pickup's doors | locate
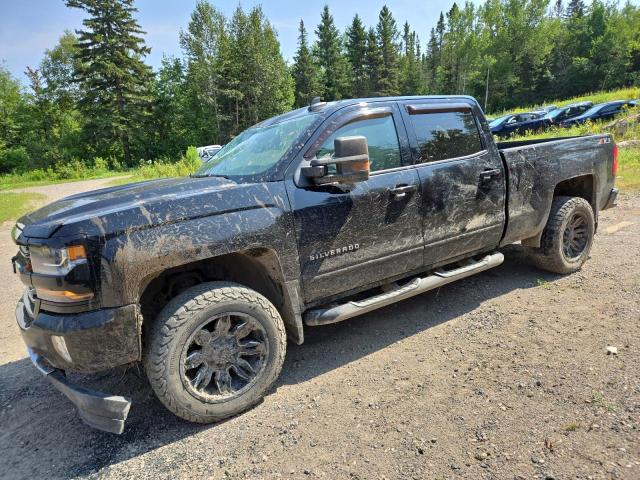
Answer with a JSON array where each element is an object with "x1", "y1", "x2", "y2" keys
[{"x1": 303, "y1": 252, "x2": 504, "y2": 326}]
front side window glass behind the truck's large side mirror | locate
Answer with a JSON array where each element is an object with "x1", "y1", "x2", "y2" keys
[{"x1": 316, "y1": 115, "x2": 402, "y2": 172}]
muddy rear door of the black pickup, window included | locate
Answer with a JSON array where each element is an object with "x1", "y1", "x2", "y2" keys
[{"x1": 401, "y1": 99, "x2": 506, "y2": 265}]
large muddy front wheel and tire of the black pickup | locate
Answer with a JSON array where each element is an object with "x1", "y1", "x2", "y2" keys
[{"x1": 144, "y1": 282, "x2": 286, "y2": 423}]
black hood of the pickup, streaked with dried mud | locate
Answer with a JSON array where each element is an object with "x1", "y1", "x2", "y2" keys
[{"x1": 18, "y1": 177, "x2": 272, "y2": 238}]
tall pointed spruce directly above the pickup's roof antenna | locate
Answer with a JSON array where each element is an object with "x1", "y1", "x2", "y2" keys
[{"x1": 314, "y1": 5, "x2": 349, "y2": 100}]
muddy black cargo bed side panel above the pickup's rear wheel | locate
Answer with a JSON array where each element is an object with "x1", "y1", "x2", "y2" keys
[{"x1": 496, "y1": 135, "x2": 614, "y2": 245}]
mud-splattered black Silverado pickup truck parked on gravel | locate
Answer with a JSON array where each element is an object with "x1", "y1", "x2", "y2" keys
[{"x1": 13, "y1": 96, "x2": 617, "y2": 433}]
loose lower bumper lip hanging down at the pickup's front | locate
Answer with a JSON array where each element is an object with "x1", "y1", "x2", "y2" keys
[{"x1": 27, "y1": 348, "x2": 131, "y2": 434}]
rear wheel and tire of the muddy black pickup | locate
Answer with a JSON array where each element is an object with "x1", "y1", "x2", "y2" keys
[{"x1": 532, "y1": 197, "x2": 595, "y2": 274}]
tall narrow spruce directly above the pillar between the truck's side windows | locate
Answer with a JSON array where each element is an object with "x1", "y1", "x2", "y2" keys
[{"x1": 376, "y1": 5, "x2": 399, "y2": 96}]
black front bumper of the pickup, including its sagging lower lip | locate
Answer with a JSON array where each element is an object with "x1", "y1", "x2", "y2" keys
[{"x1": 16, "y1": 289, "x2": 141, "y2": 433}]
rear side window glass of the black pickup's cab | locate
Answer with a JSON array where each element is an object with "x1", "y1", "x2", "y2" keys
[{"x1": 411, "y1": 110, "x2": 483, "y2": 163}]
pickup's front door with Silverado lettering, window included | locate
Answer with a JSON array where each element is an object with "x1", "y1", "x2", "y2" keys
[{"x1": 288, "y1": 102, "x2": 423, "y2": 302}]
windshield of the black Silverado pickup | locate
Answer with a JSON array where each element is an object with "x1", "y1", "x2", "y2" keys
[{"x1": 194, "y1": 114, "x2": 317, "y2": 177}]
